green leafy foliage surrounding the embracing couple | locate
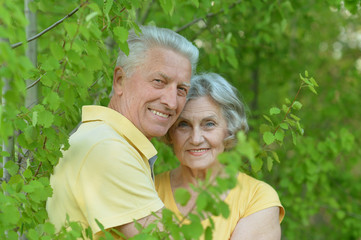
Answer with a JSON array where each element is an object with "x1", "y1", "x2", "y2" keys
[{"x1": 0, "y1": 0, "x2": 361, "y2": 239}]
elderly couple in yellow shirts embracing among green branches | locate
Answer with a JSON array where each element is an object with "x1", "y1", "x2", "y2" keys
[{"x1": 47, "y1": 27, "x2": 284, "y2": 239}]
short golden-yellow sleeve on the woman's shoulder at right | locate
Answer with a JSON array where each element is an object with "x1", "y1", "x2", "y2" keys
[{"x1": 243, "y1": 180, "x2": 285, "y2": 222}]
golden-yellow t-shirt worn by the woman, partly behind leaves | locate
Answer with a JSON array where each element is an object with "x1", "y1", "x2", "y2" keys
[{"x1": 155, "y1": 171, "x2": 285, "y2": 240}]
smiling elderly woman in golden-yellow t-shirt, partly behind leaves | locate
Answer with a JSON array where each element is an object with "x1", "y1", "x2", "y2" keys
[{"x1": 155, "y1": 73, "x2": 284, "y2": 240}]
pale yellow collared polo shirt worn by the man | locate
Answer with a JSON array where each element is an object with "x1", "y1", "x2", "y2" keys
[{"x1": 46, "y1": 106, "x2": 164, "y2": 234}]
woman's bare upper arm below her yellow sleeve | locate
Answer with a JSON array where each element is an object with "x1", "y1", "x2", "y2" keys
[{"x1": 231, "y1": 207, "x2": 281, "y2": 240}]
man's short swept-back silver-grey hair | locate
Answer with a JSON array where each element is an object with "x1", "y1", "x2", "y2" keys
[{"x1": 116, "y1": 26, "x2": 199, "y2": 77}]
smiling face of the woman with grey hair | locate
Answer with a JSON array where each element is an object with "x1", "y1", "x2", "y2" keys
[{"x1": 169, "y1": 96, "x2": 227, "y2": 170}]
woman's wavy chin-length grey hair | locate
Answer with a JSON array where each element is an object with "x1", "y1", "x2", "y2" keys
[{"x1": 187, "y1": 73, "x2": 248, "y2": 150}]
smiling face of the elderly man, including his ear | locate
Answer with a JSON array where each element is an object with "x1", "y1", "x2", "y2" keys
[{"x1": 114, "y1": 48, "x2": 191, "y2": 139}]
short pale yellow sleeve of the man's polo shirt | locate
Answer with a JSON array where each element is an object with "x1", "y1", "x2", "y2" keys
[{"x1": 76, "y1": 140, "x2": 163, "y2": 234}]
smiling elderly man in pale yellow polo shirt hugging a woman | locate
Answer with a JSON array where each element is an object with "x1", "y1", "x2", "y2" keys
[{"x1": 47, "y1": 27, "x2": 198, "y2": 237}]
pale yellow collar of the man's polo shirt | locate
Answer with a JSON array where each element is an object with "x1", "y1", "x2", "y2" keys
[{"x1": 82, "y1": 106, "x2": 157, "y2": 159}]
